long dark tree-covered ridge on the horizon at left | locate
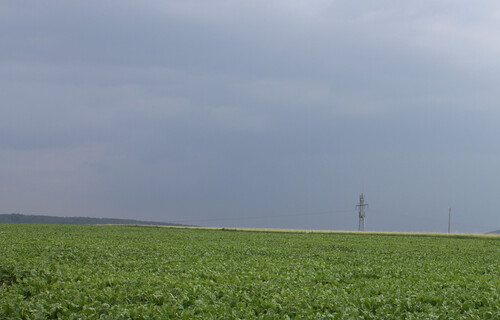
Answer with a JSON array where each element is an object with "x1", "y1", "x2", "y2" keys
[{"x1": 0, "y1": 213, "x2": 188, "y2": 226}]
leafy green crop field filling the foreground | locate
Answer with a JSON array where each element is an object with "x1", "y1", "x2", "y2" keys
[{"x1": 0, "y1": 224, "x2": 500, "y2": 319}]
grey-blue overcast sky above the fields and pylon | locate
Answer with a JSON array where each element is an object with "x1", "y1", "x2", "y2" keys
[{"x1": 0, "y1": 0, "x2": 500, "y2": 232}]
